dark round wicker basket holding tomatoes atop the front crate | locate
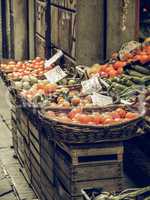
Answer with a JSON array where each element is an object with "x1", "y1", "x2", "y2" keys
[{"x1": 39, "y1": 105, "x2": 144, "y2": 144}]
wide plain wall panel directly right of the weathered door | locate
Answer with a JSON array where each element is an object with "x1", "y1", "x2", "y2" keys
[{"x1": 76, "y1": 0, "x2": 105, "y2": 65}]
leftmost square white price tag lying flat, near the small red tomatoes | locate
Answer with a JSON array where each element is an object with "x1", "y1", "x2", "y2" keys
[{"x1": 45, "y1": 65, "x2": 67, "y2": 83}]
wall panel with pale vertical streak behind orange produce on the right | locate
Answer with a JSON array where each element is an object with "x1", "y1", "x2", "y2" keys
[{"x1": 106, "y1": 0, "x2": 139, "y2": 58}]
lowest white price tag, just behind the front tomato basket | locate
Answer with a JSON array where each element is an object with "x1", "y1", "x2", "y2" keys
[{"x1": 91, "y1": 93, "x2": 113, "y2": 107}]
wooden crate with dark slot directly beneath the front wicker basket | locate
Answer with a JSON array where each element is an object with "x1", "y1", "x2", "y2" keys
[{"x1": 54, "y1": 143, "x2": 123, "y2": 196}]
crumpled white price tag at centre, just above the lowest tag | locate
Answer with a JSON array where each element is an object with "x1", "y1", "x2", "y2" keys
[{"x1": 81, "y1": 76, "x2": 102, "y2": 94}]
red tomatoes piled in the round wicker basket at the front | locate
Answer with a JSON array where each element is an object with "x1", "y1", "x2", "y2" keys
[{"x1": 47, "y1": 107, "x2": 139, "y2": 125}]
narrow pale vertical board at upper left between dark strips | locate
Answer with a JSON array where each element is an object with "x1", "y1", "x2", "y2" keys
[{"x1": 12, "y1": 0, "x2": 28, "y2": 59}]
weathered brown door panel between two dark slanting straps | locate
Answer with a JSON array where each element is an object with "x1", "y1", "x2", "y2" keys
[{"x1": 51, "y1": 7, "x2": 76, "y2": 58}]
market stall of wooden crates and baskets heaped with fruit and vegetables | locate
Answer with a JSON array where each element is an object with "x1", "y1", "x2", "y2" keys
[{"x1": 0, "y1": 40, "x2": 150, "y2": 200}]
